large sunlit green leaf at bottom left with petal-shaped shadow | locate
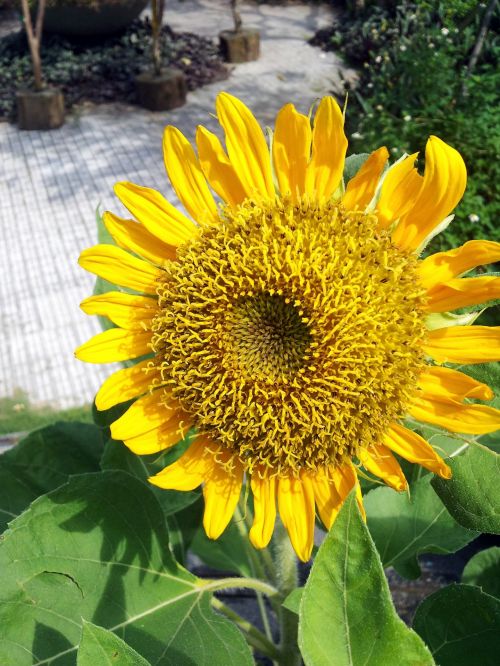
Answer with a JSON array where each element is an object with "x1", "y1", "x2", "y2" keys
[{"x1": 0, "y1": 471, "x2": 252, "y2": 666}]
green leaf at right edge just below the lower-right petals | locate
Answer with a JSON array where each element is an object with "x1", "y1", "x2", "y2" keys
[{"x1": 432, "y1": 444, "x2": 500, "y2": 534}]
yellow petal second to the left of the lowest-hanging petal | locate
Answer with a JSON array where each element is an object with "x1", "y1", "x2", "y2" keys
[{"x1": 203, "y1": 453, "x2": 243, "y2": 539}]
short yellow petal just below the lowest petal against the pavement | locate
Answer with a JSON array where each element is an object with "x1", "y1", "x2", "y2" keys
[{"x1": 111, "y1": 391, "x2": 173, "y2": 440}]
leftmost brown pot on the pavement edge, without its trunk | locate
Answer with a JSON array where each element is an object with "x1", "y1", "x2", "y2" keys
[{"x1": 16, "y1": 88, "x2": 64, "y2": 130}]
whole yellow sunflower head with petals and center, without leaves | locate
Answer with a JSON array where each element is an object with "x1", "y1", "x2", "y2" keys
[{"x1": 76, "y1": 93, "x2": 500, "y2": 561}]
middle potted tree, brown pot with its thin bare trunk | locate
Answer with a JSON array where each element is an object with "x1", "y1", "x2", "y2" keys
[{"x1": 135, "y1": 0, "x2": 187, "y2": 111}]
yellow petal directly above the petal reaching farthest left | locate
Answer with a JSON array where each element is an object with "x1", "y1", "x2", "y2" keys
[{"x1": 80, "y1": 291, "x2": 158, "y2": 330}]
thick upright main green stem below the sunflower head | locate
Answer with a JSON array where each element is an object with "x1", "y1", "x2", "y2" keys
[{"x1": 276, "y1": 525, "x2": 302, "y2": 666}]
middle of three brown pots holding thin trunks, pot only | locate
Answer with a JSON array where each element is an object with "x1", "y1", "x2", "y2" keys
[{"x1": 135, "y1": 67, "x2": 187, "y2": 111}]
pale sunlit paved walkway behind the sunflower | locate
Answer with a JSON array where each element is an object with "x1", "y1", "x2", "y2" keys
[{"x1": 0, "y1": 0, "x2": 354, "y2": 407}]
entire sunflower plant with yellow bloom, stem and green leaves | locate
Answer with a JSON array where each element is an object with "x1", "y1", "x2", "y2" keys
[{"x1": 0, "y1": 93, "x2": 500, "y2": 666}]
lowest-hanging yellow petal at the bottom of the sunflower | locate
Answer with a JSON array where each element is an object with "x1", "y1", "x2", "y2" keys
[{"x1": 278, "y1": 475, "x2": 315, "y2": 562}]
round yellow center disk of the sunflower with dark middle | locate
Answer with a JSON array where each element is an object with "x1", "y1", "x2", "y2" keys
[{"x1": 153, "y1": 200, "x2": 425, "y2": 475}]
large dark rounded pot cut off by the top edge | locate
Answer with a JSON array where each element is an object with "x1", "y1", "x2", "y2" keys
[{"x1": 43, "y1": 0, "x2": 147, "y2": 37}]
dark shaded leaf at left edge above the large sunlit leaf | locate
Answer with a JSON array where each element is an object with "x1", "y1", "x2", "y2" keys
[{"x1": 0, "y1": 422, "x2": 102, "y2": 532}]
